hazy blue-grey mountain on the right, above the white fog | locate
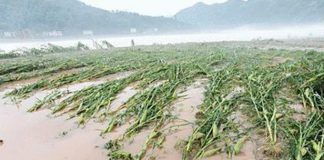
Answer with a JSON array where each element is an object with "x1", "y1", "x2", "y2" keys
[{"x1": 175, "y1": 0, "x2": 324, "y2": 28}]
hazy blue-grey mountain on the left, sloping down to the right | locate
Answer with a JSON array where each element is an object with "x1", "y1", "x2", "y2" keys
[{"x1": 0, "y1": 0, "x2": 188, "y2": 35}]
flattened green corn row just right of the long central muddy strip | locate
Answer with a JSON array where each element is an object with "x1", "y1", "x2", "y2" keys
[{"x1": 183, "y1": 64, "x2": 244, "y2": 159}]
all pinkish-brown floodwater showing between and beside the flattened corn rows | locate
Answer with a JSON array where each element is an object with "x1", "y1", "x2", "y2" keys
[{"x1": 0, "y1": 74, "x2": 264, "y2": 160}]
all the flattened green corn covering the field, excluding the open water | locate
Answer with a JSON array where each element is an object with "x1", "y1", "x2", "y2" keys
[{"x1": 0, "y1": 42, "x2": 324, "y2": 160}]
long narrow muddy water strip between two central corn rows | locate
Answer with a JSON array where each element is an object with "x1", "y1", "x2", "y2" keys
[{"x1": 146, "y1": 82, "x2": 205, "y2": 160}]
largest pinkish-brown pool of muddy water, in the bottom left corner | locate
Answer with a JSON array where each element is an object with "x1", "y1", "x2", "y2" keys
[{"x1": 0, "y1": 89, "x2": 107, "y2": 160}]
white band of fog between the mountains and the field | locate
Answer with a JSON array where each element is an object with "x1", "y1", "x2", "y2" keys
[{"x1": 0, "y1": 24, "x2": 324, "y2": 51}]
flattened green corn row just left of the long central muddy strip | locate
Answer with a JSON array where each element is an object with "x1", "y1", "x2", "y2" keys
[{"x1": 104, "y1": 65, "x2": 210, "y2": 159}]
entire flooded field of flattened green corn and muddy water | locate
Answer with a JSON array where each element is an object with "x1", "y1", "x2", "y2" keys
[{"x1": 0, "y1": 40, "x2": 324, "y2": 160}]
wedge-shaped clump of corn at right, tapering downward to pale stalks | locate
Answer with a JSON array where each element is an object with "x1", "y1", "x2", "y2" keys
[{"x1": 246, "y1": 69, "x2": 285, "y2": 145}]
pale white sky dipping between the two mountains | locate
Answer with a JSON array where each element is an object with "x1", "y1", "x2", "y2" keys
[{"x1": 80, "y1": 0, "x2": 226, "y2": 16}]
